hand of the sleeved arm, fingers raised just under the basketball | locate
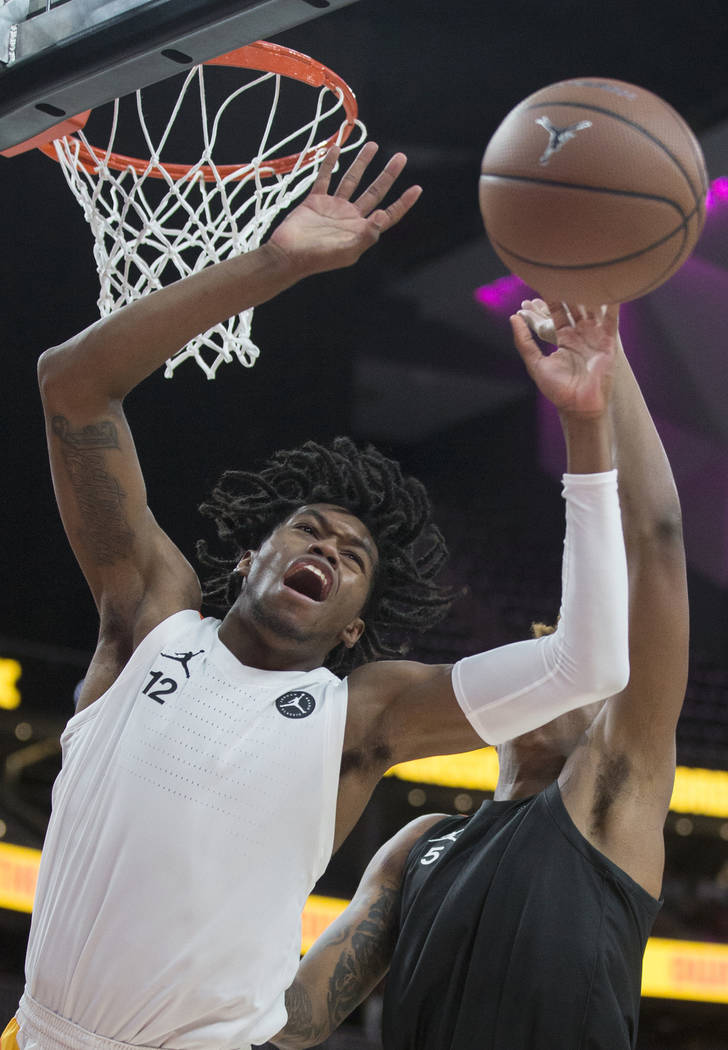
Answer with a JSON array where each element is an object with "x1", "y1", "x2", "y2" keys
[{"x1": 511, "y1": 299, "x2": 619, "y2": 418}]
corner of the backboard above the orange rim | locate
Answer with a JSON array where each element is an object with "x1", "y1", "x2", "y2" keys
[{"x1": 0, "y1": 0, "x2": 356, "y2": 151}]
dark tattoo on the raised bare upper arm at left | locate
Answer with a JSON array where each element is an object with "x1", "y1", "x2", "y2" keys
[{"x1": 50, "y1": 416, "x2": 133, "y2": 565}]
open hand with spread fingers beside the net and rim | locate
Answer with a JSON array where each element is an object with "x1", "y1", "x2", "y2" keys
[{"x1": 269, "y1": 142, "x2": 422, "y2": 273}]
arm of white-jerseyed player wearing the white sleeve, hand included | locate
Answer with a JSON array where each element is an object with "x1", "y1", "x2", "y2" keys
[{"x1": 350, "y1": 305, "x2": 628, "y2": 761}]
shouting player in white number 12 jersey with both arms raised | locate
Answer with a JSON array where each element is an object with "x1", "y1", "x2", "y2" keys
[{"x1": 3, "y1": 144, "x2": 628, "y2": 1050}]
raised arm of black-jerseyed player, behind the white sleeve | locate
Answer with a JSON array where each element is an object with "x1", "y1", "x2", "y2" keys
[{"x1": 524, "y1": 300, "x2": 689, "y2": 897}]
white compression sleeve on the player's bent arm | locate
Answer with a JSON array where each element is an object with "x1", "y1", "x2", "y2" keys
[{"x1": 452, "y1": 470, "x2": 629, "y2": 743}]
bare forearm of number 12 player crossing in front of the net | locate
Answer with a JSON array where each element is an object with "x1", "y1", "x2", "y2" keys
[{"x1": 39, "y1": 244, "x2": 304, "y2": 404}]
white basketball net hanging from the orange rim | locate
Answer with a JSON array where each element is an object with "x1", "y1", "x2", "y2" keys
[{"x1": 54, "y1": 58, "x2": 367, "y2": 379}]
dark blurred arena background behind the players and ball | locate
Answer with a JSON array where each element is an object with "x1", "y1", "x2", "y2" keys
[{"x1": 0, "y1": 0, "x2": 728, "y2": 1050}]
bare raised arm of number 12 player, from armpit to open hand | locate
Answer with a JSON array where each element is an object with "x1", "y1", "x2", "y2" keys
[{"x1": 39, "y1": 144, "x2": 419, "y2": 707}]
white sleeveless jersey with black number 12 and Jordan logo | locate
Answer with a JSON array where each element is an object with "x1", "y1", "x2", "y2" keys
[{"x1": 21, "y1": 610, "x2": 347, "y2": 1050}]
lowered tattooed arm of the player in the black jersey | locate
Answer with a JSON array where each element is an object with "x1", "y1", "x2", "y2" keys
[{"x1": 271, "y1": 814, "x2": 443, "y2": 1050}]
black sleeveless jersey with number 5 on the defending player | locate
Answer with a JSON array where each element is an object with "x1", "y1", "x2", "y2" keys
[{"x1": 382, "y1": 782, "x2": 660, "y2": 1050}]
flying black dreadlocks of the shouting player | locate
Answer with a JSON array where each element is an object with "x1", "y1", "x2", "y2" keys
[{"x1": 197, "y1": 438, "x2": 456, "y2": 674}]
